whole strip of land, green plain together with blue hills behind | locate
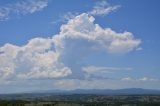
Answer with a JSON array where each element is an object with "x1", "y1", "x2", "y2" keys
[{"x1": 0, "y1": 88, "x2": 160, "y2": 106}]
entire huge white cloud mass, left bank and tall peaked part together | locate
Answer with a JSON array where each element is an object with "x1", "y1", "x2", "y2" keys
[{"x1": 0, "y1": 13, "x2": 141, "y2": 79}]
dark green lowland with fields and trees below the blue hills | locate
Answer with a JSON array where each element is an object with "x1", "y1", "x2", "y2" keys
[{"x1": 0, "y1": 94, "x2": 160, "y2": 106}]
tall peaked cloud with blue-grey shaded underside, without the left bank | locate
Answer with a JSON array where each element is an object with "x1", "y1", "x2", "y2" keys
[{"x1": 53, "y1": 13, "x2": 141, "y2": 78}]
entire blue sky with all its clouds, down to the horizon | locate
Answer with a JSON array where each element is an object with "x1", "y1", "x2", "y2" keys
[{"x1": 0, "y1": 0, "x2": 160, "y2": 93}]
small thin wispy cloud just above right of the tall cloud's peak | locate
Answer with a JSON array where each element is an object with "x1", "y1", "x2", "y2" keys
[{"x1": 88, "y1": 1, "x2": 120, "y2": 16}]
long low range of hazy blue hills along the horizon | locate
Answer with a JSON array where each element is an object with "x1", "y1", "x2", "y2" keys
[{"x1": 25, "y1": 88, "x2": 160, "y2": 95}]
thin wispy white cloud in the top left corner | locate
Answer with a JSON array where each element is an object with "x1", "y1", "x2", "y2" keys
[{"x1": 0, "y1": 0, "x2": 49, "y2": 21}]
